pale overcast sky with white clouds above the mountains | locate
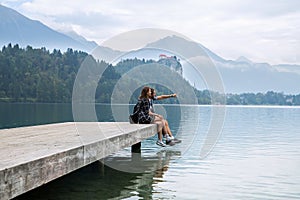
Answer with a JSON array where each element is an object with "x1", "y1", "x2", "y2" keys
[{"x1": 0, "y1": 0, "x2": 300, "y2": 64}]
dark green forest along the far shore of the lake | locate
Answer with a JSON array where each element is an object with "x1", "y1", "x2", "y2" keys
[{"x1": 0, "y1": 44, "x2": 300, "y2": 105}]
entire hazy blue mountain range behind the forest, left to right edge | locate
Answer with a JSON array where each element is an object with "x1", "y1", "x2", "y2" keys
[{"x1": 0, "y1": 5, "x2": 300, "y2": 94}]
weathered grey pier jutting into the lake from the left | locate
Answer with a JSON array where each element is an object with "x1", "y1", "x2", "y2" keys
[{"x1": 0, "y1": 122, "x2": 157, "y2": 200}]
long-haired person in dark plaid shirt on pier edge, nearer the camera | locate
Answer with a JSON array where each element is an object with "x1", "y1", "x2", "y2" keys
[{"x1": 138, "y1": 86, "x2": 166, "y2": 147}]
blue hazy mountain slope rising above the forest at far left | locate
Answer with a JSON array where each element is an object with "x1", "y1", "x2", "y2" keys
[{"x1": 0, "y1": 5, "x2": 97, "y2": 52}]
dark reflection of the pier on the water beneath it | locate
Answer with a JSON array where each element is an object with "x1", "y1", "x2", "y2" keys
[{"x1": 17, "y1": 150, "x2": 181, "y2": 200}]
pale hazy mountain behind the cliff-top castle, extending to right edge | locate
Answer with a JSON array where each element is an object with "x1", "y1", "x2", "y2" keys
[{"x1": 147, "y1": 36, "x2": 300, "y2": 94}]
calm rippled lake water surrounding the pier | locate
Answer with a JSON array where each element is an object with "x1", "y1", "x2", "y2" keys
[{"x1": 0, "y1": 104, "x2": 300, "y2": 200}]
